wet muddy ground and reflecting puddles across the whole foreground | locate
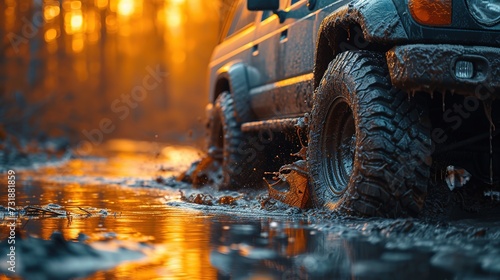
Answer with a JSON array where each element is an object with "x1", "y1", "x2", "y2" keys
[{"x1": 0, "y1": 141, "x2": 500, "y2": 279}]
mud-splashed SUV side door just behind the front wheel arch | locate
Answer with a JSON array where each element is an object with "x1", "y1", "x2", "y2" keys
[{"x1": 250, "y1": 0, "x2": 316, "y2": 119}]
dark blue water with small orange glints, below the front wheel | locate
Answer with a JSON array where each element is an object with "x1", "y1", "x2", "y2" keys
[{"x1": 210, "y1": 222, "x2": 452, "y2": 279}]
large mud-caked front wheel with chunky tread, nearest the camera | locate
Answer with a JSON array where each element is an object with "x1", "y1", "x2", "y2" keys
[{"x1": 307, "y1": 51, "x2": 431, "y2": 217}]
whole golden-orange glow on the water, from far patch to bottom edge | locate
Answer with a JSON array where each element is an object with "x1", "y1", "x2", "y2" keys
[{"x1": 0, "y1": 141, "x2": 215, "y2": 279}]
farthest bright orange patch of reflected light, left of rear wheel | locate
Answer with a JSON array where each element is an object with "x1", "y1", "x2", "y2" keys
[{"x1": 33, "y1": 139, "x2": 203, "y2": 182}]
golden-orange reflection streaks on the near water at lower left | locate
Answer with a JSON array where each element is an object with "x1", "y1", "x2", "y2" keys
[{"x1": 6, "y1": 182, "x2": 219, "y2": 279}]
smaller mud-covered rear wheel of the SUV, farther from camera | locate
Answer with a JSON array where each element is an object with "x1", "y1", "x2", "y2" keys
[{"x1": 208, "y1": 92, "x2": 263, "y2": 189}]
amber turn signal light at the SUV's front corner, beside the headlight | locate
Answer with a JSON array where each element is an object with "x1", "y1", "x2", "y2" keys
[{"x1": 408, "y1": 0, "x2": 452, "y2": 25}]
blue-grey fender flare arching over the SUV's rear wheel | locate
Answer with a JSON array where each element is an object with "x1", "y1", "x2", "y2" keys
[{"x1": 210, "y1": 61, "x2": 259, "y2": 122}]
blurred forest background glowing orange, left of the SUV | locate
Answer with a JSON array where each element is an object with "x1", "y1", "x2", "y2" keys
[{"x1": 0, "y1": 0, "x2": 234, "y2": 148}]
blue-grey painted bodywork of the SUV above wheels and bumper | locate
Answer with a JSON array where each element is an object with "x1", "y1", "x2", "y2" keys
[{"x1": 210, "y1": 0, "x2": 500, "y2": 118}]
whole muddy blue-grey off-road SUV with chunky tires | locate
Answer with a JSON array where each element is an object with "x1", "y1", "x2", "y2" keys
[{"x1": 207, "y1": 0, "x2": 500, "y2": 217}]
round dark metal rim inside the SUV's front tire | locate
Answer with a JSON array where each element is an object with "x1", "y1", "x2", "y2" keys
[{"x1": 322, "y1": 98, "x2": 356, "y2": 195}]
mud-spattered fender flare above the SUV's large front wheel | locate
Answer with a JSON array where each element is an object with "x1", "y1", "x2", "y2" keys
[{"x1": 314, "y1": 0, "x2": 408, "y2": 88}]
